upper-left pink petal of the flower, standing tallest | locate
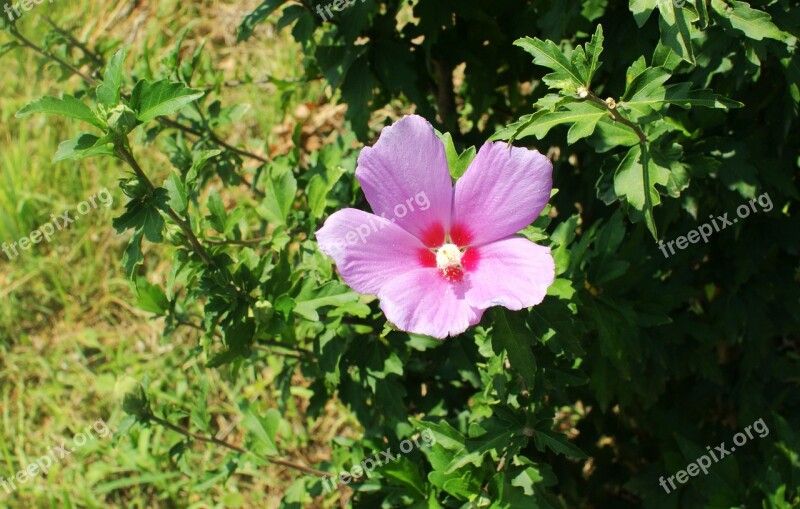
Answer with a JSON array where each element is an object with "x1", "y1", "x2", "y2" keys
[{"x1": 356, "y1": 116, "x2": 453, "y2": 245}]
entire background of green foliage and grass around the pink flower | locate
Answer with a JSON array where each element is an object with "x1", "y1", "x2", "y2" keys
[{"x1": 0, "y1": 0, "x2": 800, "y2": 508}]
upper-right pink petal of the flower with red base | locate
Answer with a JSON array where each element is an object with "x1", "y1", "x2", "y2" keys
[{"x1": 451, "y1": 143, "x2": 553, "y2": 246}]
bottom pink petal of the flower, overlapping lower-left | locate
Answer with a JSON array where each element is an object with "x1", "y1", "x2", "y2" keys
[{"x1": 378, "y1": 268, "x2": 483, "y2": 339}]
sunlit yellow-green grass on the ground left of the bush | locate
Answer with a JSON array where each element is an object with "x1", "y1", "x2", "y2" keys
[{"x1": 0, "y1": 0, "x2": 343, "y2": 508}]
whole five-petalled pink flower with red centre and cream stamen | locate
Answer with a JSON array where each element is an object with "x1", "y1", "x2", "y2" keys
[{"x1": 317, "y1": 116, "x2": 555, "y2": 339}]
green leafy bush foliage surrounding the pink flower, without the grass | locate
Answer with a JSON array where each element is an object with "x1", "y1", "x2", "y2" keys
[{"x1": 5, "y1": 0, "x2": 800, "y2": 509}]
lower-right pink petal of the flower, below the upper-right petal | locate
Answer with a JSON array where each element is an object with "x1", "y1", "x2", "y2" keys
[{"x1": 466, "y1": 237, "x2": 555, "y2": 311}]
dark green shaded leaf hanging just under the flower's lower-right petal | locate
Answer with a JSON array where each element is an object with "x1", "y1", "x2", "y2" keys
[{"x1": 492, "y1": 308, "x2": 536, "y2": 390}]
